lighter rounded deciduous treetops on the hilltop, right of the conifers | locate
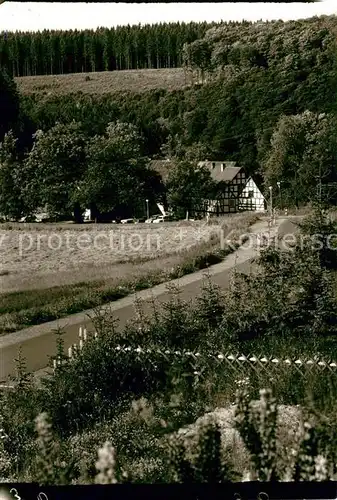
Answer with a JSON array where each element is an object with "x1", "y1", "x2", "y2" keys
[{"x1": 182, "y1": 16, "x2": 337, "y2": 80}]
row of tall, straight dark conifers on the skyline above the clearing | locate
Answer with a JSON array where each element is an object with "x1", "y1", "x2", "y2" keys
[{"x1": 0, "y1": 22, "x2": 215, "y2": 77}]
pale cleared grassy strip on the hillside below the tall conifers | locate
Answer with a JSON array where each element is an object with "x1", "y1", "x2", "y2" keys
[{"x1": 15, "y1": 68, "x2": 185, "y2": 97}]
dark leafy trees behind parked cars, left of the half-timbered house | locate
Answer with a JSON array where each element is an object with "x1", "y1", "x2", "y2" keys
[{"x1": 0, "y1": 121, "x2": 215, "y2": 222}]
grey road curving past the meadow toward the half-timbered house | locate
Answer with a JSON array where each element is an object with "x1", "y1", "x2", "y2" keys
[{"x1": 0, "y1": 218, "x2": 296, "y2": 381}]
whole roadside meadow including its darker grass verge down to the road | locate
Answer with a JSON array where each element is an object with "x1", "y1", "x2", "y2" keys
[{"x1": 0, "y1": 214, "x2": 257, "y2": 334}]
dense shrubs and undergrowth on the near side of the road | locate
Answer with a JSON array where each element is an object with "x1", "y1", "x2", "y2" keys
[{"x1": 1, "y1": 210, "x2": 337, "y2": 482}]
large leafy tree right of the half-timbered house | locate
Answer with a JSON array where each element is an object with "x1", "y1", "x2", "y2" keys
[{"x1": 263, "y1": 111, "x2": 337, "y2": 204}]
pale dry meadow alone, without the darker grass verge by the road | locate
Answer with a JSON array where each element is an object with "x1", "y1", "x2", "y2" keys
[{"x1": 0, "y1": 219, "x2": 231, "y2": 292}]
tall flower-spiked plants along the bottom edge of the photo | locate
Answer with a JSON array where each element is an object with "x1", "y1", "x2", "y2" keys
[{"x1": 1, "y1": 390, "x2": 337, "y2": 485}]
